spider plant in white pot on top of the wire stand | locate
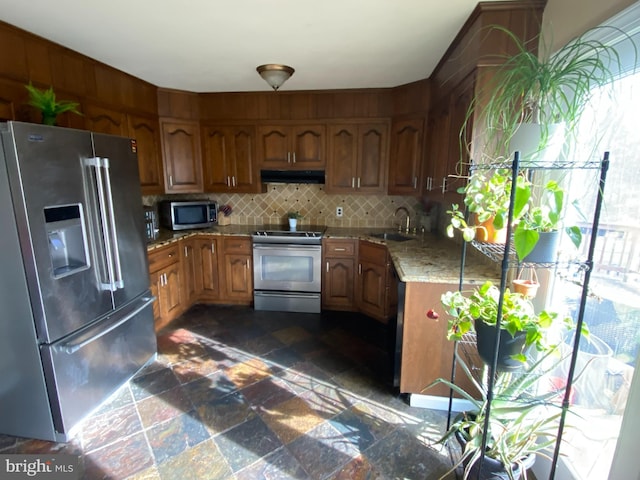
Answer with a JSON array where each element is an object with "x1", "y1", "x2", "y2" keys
[{"x1": 460, "y1": 25, "x2": 635, "y2": 162}]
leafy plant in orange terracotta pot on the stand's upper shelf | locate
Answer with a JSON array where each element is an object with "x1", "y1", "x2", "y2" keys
[{"x1": 447, "y1": 169, "x2": 531, "y2": 243}]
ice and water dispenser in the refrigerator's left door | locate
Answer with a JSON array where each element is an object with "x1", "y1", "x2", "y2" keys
[{"x1": 44, "y1": 204, "x2": 89, "y2": 278}]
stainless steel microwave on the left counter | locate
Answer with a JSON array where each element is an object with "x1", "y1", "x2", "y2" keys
[{"x1": 158, "y1": 200, "x2": 218, "y2": 230}]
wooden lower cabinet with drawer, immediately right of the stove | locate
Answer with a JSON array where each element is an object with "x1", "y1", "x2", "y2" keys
[{"x1": 322, "y1": 239, "x2": 358, "y2": 311}]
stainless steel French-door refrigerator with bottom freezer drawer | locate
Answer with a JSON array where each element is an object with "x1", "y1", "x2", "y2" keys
[{"x1": 0, "y1": 122, "x2": 156, "y2": 441}]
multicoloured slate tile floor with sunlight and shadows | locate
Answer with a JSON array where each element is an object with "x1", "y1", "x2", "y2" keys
[{"x1": 0, "y1": 305, "x2": 454, "y2": 480}]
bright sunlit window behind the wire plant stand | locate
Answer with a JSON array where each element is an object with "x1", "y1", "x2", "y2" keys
[{"x1": 550, "y1": 16, "x2": 640, "y2": 480}]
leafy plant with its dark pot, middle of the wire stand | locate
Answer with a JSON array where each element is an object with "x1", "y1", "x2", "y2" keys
[{"x1": 440, "y1": 281, "x2": 573, "y2": 370}]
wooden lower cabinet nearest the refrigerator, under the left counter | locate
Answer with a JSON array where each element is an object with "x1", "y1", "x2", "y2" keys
[{"x1": 149, "y1": 243, "x2": 184, "y2": 330}]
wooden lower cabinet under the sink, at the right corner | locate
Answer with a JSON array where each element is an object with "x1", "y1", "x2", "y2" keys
[{"x1": 356, "y1": 241, "x2": 397, "y2": 323}]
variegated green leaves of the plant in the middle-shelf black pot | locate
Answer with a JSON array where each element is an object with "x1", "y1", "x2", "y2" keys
[{"x1": 440, "y1": 281, "x2": 573, "y2": 356}]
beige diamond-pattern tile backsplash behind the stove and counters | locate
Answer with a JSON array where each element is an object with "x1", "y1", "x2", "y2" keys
[{"x1": 142, "y1": 184, "x2": 435, "y2": 230}]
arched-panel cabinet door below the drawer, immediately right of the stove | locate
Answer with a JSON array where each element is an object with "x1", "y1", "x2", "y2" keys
[{"x1": 322, "y1": 257, "x2": 355, "y2": 310}]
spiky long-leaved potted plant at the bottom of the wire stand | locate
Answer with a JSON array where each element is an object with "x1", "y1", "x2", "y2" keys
[{"x1": 425, "y1": 349, "x2": 563, "y2": 480}]
